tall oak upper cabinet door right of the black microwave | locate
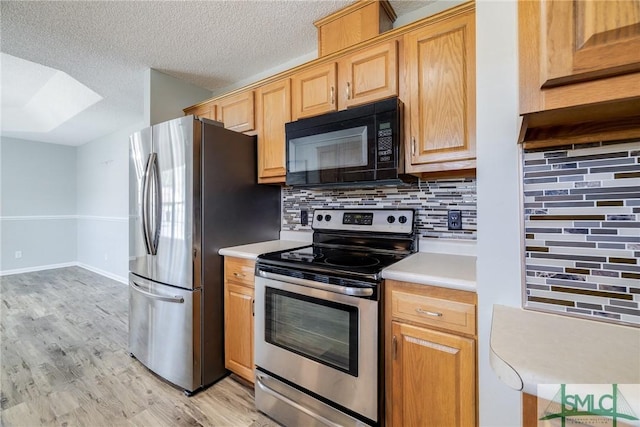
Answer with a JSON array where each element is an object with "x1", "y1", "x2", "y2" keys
[{"x1": 405, "y1": 12, "x2": 476, "y2": 172}]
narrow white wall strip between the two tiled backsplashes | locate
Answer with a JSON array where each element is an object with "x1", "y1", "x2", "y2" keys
[{"x1": 476, "y1": 0, "x2": 522, "y2": 427}]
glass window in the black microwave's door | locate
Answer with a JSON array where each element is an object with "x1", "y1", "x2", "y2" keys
[{"x1": 288, "y1": 126, "x2": 368, "y2": 172}]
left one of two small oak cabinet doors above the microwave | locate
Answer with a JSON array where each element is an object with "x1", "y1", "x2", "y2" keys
[{"x1": 291, "y1": 62, "x2": 338, "y2": 120}]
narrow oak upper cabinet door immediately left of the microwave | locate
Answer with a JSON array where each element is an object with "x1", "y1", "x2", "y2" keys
[{"x1": 258, "y1": 79, "x2": 291, "y2": 183}]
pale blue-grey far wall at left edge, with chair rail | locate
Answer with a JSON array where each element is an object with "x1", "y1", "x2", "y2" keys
[{"x1": 0, "y1": 138, "x2": 77, "y2": 274}]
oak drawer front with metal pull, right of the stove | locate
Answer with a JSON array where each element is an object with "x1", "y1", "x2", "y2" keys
[{"x1": 391, "y1": 290, "x2": 476, "y2": 335}]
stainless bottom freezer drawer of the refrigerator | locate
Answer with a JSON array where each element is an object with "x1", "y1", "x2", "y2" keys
[{"x1": 129, "y1": 274, "x2": 202, "y2": 391}]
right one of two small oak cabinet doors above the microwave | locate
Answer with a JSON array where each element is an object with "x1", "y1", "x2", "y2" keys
[{"x1": 338, "y1": 40, "x2": 398, "y2": 109}]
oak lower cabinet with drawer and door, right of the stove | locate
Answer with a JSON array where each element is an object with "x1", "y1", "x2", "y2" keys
[{"x1": 385, "y1": 280, "x2": 477, "y2": 427}]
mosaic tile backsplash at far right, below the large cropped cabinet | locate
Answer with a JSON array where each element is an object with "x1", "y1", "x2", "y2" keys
[{"x1": 523, "y1": 141, "x2": 640, "y2": 326}]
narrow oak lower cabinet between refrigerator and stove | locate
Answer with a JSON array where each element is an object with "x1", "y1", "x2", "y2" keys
[{"x1": 224, "y1": 257, "x2": 255, "y2": 383}]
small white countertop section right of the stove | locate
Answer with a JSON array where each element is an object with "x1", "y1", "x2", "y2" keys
[{"x1": 382, "y1": 252, "x2": 476, "y2": 292}]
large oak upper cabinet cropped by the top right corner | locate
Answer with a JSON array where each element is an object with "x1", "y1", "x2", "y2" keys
[{"x1": 518, "y1": 0, "x2": 640, "y2": 114}]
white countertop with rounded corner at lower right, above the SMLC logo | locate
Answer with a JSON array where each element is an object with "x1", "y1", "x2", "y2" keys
[{"x1": 490, "y1": 305, "x2": 640, "y2": 395}]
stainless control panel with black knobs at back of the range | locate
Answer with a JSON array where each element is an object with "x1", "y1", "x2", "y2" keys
[{"x1": 312, "y1": 209, "x2": 414, "y2": 234}]
